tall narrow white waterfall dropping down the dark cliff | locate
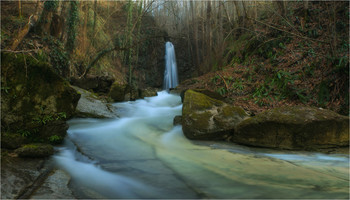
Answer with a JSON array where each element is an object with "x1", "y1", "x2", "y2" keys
[{"x1": 163, "y1": 42, "x2": 178, "y2": 90}]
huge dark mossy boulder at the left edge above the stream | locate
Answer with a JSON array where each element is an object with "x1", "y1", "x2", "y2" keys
[{"x1": 1, "y1": 53, "x2": 80, "y2": 132}]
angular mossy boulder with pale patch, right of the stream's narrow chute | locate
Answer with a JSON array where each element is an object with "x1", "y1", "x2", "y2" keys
[{"x1": 182, "y1": 90, "x2": 248, "y2": 140}]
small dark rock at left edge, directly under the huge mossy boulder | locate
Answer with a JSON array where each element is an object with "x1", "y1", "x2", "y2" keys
[{"x1": 1, "y1": 132, "x2": 28, "y2": 149}]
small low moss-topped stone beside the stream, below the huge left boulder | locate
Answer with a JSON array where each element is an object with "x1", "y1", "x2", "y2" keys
[{"x1": 15, "y1": 143, "x2": 54, "y2": 158}]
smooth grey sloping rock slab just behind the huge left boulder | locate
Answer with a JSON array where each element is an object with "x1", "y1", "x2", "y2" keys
[{"x1": 72, "y1": 86, "x2": 117, "y2": 118}]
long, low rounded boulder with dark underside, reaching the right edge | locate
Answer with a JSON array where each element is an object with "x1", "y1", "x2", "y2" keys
[{"x1": 232, "y1": 106, "x2": 349, "y2": 150}]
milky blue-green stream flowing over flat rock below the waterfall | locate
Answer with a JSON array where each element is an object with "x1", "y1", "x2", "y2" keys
[{"x1": 55, "y1": 92, "x2": 349, "y2": 198}]
